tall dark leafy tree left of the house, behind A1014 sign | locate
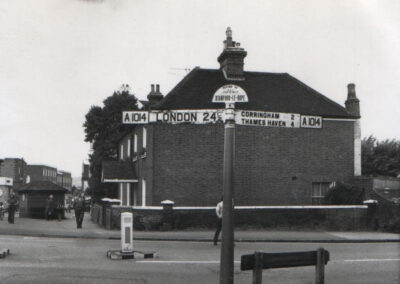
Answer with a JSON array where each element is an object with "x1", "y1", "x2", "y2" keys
[{"x1": 83, "y1": 85, "x2": 138, "y2": 201}]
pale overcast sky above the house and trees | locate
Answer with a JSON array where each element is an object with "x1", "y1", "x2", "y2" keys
[{"x1": 0, "y1": 0, "x2": 400, "y2": 177}]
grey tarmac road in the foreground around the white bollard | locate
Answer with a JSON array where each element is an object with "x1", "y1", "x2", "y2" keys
[{"x1": 0, "y1": 235, "x2": 400, "y2": 284}]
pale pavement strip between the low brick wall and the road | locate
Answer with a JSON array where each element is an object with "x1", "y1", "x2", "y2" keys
[{"x1": 0, "y1": 213, "x2": 400, "y2": 243}]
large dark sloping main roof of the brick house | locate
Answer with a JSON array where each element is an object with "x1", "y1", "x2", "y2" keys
[{"x1": 157, "y1": 67, "x2": 358, "y2": 118}]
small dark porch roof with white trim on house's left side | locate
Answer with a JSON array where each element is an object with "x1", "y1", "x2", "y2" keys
[{"x1": 102, "y1": 161, "x2": 138, "y2": 182}]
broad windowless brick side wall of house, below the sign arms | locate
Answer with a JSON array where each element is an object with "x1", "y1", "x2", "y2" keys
[{"x1": 146, "y1": 118, "x2": 354, "y2": 206}]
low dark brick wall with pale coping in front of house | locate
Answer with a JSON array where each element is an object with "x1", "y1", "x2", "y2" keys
[{"x1": 92, "y1": 202, "x2": 370, "y2": 230}]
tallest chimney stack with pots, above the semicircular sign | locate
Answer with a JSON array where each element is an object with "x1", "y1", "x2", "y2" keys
[{"x1": 218, "y1": 27, "x2": 247, "y2": 80}]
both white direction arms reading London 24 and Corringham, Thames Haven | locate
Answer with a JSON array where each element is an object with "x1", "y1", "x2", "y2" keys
[{"x1": 122, "y1": 109, "x2": 322, "y2": 128}]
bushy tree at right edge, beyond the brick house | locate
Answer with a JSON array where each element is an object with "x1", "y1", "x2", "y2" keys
[{"x1": 361, "y1": 135, "x2": 400, "y2": 177}]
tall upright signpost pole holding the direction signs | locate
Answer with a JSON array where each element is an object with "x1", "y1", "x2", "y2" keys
[{"x1": 220, "y1": 103, "x2": 235, "y2": 284}]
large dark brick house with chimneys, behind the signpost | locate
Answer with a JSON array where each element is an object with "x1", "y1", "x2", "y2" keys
[{"x1": 103, "y1": 29, "x2": 361, "y2": 206}]
